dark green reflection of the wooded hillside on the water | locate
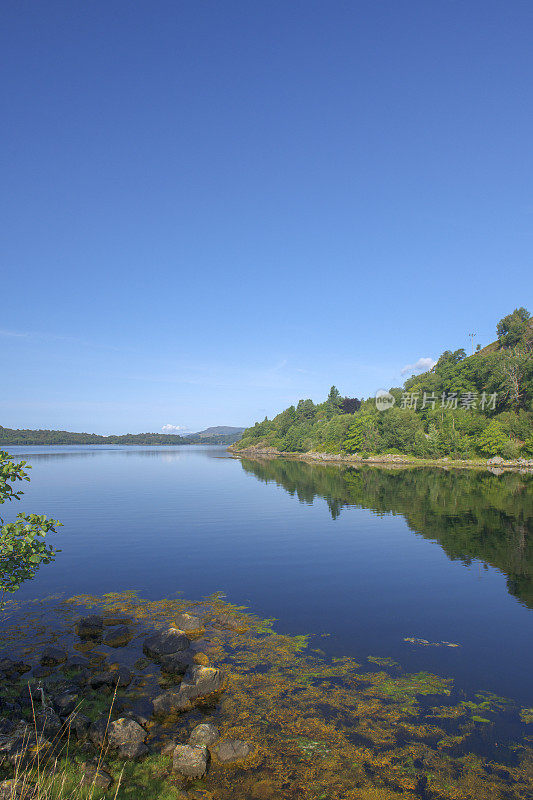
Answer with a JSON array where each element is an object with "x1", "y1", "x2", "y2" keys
[{"x1": 242, "y1": 459, "x2": 533, "y2": 607}]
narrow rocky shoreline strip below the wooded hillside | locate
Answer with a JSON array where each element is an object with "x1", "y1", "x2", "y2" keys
[{"x1": 227, "y1": 445, "x2": 533, "y2": 474}]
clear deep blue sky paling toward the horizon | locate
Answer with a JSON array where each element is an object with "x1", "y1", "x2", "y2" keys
[{"x1": 0, "y1": 0, "x2": 533, "y2": 433}]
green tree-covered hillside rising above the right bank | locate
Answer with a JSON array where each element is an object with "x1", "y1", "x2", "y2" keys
[{"x1": 235, "y1": 308, "x2": 533, "y2": 459}]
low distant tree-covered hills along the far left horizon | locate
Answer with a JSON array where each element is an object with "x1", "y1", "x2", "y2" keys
[{"x1": 0, "y1": 425, "x2": 244, "y2": 449}]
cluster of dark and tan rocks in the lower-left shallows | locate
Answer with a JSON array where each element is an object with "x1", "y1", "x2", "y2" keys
[{"x1": 0, "y1": 613, "x2": 254, "y2": 800}]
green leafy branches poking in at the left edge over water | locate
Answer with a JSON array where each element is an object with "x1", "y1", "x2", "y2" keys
[{"x1": 0, "y1": 451, "x2": 61, "y2": 610}]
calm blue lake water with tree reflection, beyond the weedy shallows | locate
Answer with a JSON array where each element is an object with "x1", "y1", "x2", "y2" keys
[{"x1": 2, "y1": 447, "x2": 533, "y2": 705}]
